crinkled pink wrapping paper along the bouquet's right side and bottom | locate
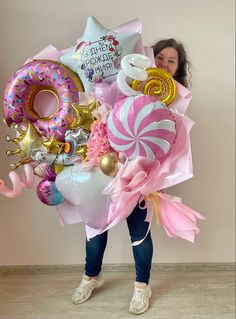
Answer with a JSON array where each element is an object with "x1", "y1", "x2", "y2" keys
[{"x1": 54, "y1": 85, "x2": 203, "y2": 242}]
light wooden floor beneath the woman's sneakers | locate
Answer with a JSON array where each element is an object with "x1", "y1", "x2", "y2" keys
[{"x1": 0, "y1": 270, "x2": 235, "y2": 319}]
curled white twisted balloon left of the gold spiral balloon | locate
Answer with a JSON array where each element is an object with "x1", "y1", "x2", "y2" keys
[{"x1": 117, "y1": 54, "x2": 151, "y2": 96}]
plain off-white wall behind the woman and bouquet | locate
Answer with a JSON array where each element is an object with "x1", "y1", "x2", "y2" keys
[{"x1": 0, "y1": 0, "x2": 235, "y2": 265}]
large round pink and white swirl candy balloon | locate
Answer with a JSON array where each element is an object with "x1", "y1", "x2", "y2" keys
[{"x1": 107, "y1": 95, "x2": 176, "y2": 160}]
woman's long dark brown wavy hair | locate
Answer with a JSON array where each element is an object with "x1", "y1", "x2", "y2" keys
[{"x1": 152, "y1": 39, "x2": 191, "y2": 88}]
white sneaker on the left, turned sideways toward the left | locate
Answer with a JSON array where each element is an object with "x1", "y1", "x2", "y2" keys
[{"x1": 72, "y1": 274, "x2": 104, "y2": 305}]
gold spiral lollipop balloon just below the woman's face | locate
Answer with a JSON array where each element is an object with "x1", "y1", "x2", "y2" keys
[{"x1": 130, "y1": 68, "x2": 176, "y2": 106}]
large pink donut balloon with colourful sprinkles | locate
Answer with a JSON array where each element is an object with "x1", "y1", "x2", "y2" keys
[{"x1": 3, "y1": 60, "x2": 83, "y2": 140}]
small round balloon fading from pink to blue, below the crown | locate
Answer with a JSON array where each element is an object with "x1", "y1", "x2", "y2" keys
[{"x1": 37, "y1": 179, "x2": 64, "y2": 206}]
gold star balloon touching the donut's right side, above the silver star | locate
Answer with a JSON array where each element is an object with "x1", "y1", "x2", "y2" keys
[{"x1": 71, "y1": 101, "x2": 98, "y2": 132}]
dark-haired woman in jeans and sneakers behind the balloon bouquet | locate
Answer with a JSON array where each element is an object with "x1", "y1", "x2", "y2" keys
[{"x1": 72, "y1": 39, "x2": 189, "y2": 314}]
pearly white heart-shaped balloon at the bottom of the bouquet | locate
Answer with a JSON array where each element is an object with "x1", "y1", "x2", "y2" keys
[{"x1": 56, "y1": 164, "x2": 112, "y2": 229}]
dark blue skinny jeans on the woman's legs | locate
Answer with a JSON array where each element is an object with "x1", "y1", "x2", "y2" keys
[{"x1": 85, "y1": 205, "x2": 153, "y2": 284}]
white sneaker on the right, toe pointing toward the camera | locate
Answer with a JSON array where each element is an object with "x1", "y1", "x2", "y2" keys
[{"x1": 129, "y1": 281, "x2": 152, "y2": 315}]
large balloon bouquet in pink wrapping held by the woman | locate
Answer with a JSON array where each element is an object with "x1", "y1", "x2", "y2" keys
[{"x1": 0, "y1": 17, "x2": 203, "y2": 242}]
